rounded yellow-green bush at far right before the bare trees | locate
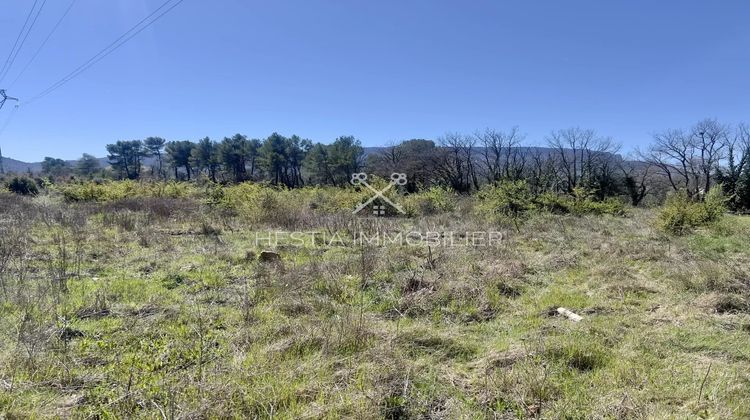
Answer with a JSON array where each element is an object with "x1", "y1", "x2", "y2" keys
[{"x1": 657, "y1": 185, "x2": 727, "y2": 235}]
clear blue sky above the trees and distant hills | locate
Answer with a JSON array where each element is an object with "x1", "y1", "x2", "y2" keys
[{"x1": 0, "y1": 0, "x2": 750, "y2": 161}]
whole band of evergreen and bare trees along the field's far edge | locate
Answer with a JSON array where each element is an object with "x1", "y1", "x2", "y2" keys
[{"x1": 26, "y1": 119, "x2": 750, "y2": 209}]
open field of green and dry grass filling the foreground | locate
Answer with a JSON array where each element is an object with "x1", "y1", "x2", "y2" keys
[{"x1": 0, "y1": 189, "x2": 750, "y2": 419}]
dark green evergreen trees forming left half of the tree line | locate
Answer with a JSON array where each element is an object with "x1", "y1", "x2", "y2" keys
[{"x1": 67, "y1": 133, "x2": 364, "y2": 188}]
